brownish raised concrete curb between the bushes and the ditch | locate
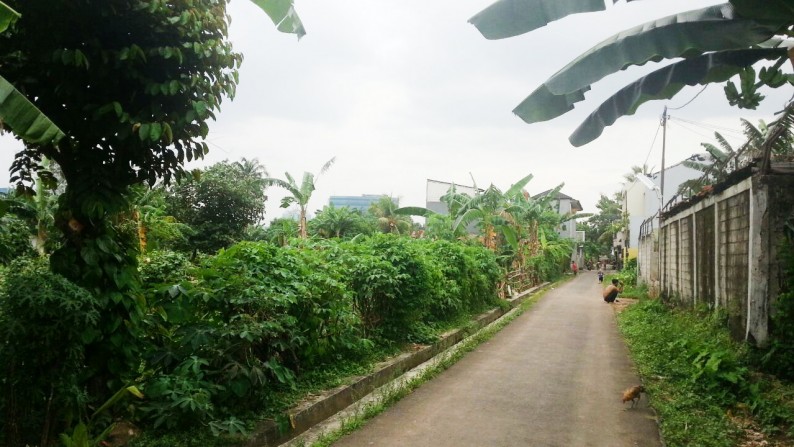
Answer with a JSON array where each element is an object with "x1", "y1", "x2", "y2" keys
[{"x1": 246, "y1": 282, "x2": 550, "y2": 447}]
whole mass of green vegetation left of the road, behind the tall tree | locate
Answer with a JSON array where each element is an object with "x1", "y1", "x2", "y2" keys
[{"x1": 0, "y1": 154, "x2": 570, "y2": 446}]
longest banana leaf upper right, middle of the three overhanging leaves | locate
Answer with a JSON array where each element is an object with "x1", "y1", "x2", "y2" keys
[{"x1": 513, "y1": 3, "x2": 786, "y2": 123}]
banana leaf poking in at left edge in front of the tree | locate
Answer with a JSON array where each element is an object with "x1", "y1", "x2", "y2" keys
[{"x1": 0, "y1": 76, "x2": 64, "y2": 144}]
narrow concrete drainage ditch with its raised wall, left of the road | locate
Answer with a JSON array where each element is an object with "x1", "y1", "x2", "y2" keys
[{"x1": 247, "y1": 283, "x2": 549, "y2": 447}]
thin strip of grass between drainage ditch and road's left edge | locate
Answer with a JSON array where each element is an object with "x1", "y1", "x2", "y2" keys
[{"x1": 292, "y1": 283, "x2": 557, "y2": 447}]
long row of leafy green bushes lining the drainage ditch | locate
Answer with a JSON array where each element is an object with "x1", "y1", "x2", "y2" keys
[{"x1": 133, "y1": 238, "x2": 500, "y2": 429}]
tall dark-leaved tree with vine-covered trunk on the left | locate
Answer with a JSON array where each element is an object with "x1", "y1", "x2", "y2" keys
[{"x1": 0, "y1": 0, "x2": 242, "y2": 416}]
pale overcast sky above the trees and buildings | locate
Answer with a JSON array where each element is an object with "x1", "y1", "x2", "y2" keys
[{"x1": 0, "y1": 0, "x2": 792, "y2": 221}]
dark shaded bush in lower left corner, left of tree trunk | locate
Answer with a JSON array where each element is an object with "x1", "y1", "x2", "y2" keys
[{"x1": 0, "y1": 259, "x2": 101, "y2": 445}]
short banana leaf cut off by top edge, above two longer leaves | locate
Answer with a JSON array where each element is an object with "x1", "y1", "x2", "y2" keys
[{"x1": 469, "y1": 0, "x2": 606, "y2": 39}]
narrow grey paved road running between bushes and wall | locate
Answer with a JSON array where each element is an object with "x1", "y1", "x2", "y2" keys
[{"x1": 335, "y1": 271, "x2": 662, "y2": 447}]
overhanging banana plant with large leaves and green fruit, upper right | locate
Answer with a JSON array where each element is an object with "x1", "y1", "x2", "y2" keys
[{"x1": 470, "y1": 0, "x2": 794, "y2": 146}]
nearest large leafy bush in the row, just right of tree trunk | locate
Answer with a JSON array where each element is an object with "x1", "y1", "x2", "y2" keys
[{"x1": 138, "y1": 242, "x2": 367, "y2": 425}]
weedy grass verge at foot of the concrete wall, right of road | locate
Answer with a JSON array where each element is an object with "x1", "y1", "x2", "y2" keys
[{"x1": 618, "y1": 299, "x2": 794, "y2": 447}]
